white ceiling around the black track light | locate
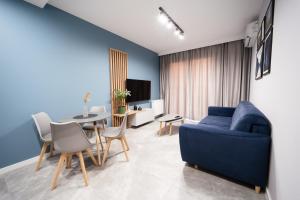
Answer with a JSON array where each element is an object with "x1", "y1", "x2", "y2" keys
[{"x1": 48, "y1": 0, "x2": 265, "y2": 55}]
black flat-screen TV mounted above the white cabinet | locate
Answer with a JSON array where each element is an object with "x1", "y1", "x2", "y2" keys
[{"x1": 126, "y1": 79, "x2": 151, "y2": 102}]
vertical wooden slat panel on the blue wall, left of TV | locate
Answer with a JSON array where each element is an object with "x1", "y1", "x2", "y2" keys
[{"x1": 109, "y1": 49, "x2": 128, "y2": 126}]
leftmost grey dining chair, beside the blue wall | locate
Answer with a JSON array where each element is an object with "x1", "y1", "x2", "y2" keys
[{"x1": 32, "y1": 112, "x2": 54, "y2": 171}]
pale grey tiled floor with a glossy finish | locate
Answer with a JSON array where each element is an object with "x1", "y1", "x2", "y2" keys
[{"x1": 0, "y1": 122, "x2": 265, "y2": 200}]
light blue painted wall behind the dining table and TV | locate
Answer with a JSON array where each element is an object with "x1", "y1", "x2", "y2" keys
[{"x1": 0, "y1": 0, "x2": 159, "y2": 168}]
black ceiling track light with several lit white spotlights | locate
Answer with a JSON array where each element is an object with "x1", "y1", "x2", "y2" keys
[{"x1": 158, "y1": 7, "x2": 184, "y2": 40}]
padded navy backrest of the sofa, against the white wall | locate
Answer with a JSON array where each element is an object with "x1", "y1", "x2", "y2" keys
[{"x1": 230, "y1": 101, "x2": 271, "y2": 134}]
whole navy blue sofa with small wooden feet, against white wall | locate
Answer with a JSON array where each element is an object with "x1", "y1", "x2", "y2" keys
[{"x1": 179, "y1": 101, "x2": 271, "y2": 188}]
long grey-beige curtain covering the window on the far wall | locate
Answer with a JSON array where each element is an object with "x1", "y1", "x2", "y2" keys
[{"x1": 160, "y1": 40, "x2": 251, "y2": 120}]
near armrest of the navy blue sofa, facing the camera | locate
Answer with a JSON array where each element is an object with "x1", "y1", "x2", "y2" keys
[{"x1": 179, "y1": 124, "x2": 271, "y2": 187}]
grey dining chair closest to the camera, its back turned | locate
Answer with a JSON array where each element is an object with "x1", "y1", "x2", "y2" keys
[{"x1": 51, "y1": 122, "x2": 98, "y2": 190}]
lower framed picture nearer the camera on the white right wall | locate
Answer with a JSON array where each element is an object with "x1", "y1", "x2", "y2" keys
[{"x1": 263, "y1": 29, "x2": 273, "y2": 75}]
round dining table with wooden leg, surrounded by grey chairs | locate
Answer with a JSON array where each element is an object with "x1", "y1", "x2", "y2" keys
[{"x1": 60, "y1": 112, "x2": 111, "y2": 166}]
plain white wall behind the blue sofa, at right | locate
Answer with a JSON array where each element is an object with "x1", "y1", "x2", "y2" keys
[{"x1": 250, "y1": 0, "x2": 300, "y2": 200}]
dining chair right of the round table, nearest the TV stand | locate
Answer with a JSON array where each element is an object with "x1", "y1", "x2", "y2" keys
[{"x1": 102, "y1": 113, "x2": 129, "y2": 165}]
